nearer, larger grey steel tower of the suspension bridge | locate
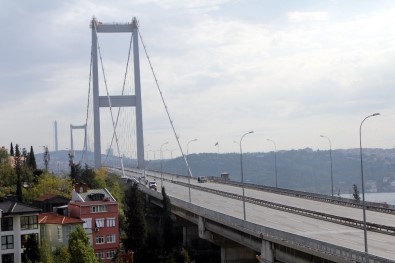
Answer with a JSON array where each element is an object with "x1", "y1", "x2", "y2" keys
[{"x1": 90, "y1": 17, "x2": 144, "y2": 169}]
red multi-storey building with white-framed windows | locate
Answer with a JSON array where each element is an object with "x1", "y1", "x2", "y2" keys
[{"x1": 68, "y1": 184, "x2": 119, "y2": 263}]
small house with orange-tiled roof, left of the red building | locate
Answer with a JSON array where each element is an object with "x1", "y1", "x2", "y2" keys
[{"x1": 38, "y1": 212, "x2": 84, "y2": 251}]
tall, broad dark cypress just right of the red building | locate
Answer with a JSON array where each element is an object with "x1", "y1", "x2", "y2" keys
[{"x1": 124, "y1": 184, "x2": 147, "y2": 253}]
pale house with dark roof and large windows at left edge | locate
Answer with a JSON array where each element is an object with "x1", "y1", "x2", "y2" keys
[{"x1": 0, "y1": 196, "x2": 40, "y2": 263}]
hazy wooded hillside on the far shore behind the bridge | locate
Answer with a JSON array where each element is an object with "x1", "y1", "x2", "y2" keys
[{"x1": 36, "y1": 148, "x2": 395, "y2": 194}]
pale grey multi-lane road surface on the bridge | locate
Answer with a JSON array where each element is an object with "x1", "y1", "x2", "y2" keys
[{"x1": 113, "y1": 168, "x2": 395, "y2": 260}]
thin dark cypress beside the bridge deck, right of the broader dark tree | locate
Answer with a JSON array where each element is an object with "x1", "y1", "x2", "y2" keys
[{"x1": 162, "y1": 187, "x2": 173, "y2": 252}]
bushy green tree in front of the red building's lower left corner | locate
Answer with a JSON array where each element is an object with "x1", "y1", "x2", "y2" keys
[{"x1": 69, "y1": 225, "x2": 98, "y2": 263}]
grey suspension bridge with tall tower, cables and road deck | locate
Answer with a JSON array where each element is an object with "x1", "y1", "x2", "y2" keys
[{"x1": 70, "y1": 18, "x2": 395, "y2": 263}]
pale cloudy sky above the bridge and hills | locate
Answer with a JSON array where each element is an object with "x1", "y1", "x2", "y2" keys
[{"x1": 0, "y1": 0, "x2": 395, "y2": 158}]
